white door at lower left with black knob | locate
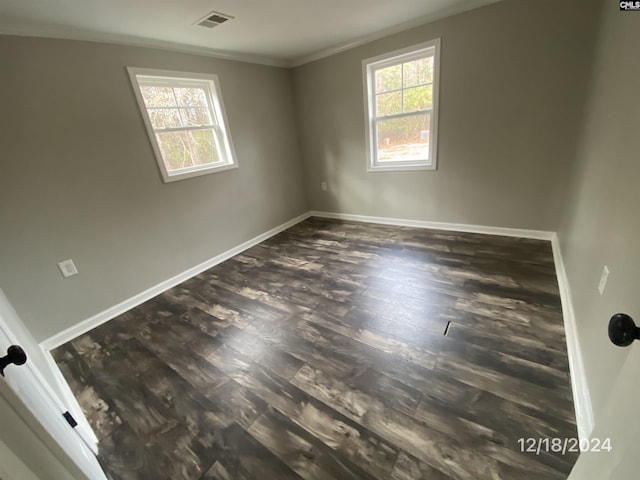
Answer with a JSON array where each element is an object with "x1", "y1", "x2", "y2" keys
[{"x1": 0, "y1": 290, "x2": 106, "y2": 480}]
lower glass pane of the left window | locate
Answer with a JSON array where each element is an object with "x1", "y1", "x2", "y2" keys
[{"x1": 156, "y1": 129, "x2": 219, "y2": 172}]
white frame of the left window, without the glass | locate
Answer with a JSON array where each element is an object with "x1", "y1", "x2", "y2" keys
[{"x1": 127, "y1": 67, "x2": 238, "y2": 183}]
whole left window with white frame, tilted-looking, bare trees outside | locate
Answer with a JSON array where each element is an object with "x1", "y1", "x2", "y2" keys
[{"x1": 128, "y1": 68, "x2": 238, "y2": 182}]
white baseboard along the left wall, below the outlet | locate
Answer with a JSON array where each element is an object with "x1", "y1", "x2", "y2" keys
[{"x1": 40, "y1": 212, "x2": 310, "y2": 353}]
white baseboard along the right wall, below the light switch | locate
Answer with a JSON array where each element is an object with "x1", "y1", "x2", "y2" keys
[{"x1": 551, "y1": 233, "x2": 595, "y2": 440}]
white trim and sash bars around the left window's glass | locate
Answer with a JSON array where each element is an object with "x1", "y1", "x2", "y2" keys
[{"x1": 127, "y1": 67, "x2": 238, "y2": 183}]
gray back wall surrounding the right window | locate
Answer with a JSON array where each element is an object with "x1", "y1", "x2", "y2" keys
[{"x1": 294, "y1": 0, "x2": 598, "y2": 230}]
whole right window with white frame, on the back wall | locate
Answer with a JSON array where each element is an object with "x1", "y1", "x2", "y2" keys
[{"x1": 362, "y1": 39, "x2": 440, "y2": 172}]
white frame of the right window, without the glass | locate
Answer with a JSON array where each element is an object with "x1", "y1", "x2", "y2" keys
[{"x1": 362, "y1": 38, "x2": 440, "y2": 172}]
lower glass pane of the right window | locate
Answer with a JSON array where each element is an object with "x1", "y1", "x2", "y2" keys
[{"x1": 377, "y1": 113, "x2": 431, "y2": 163}]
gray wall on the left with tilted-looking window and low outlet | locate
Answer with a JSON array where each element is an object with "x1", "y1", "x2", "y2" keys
[{"x1": 0, "y1": 36, "x2": 307, "y2": 341}]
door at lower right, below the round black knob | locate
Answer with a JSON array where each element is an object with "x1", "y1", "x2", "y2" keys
[{"x1": 569, "y1": 332, "x2": 640, "y2": 480}]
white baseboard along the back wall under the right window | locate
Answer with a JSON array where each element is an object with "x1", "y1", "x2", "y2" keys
[{"x1": 310, "y1": 210, "x2": 554, "y2": 241}]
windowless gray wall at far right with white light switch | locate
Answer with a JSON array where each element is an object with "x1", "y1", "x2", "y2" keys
[{"x1": 558, "y1": 2, "x2": 640, "y2": 425}]
